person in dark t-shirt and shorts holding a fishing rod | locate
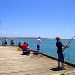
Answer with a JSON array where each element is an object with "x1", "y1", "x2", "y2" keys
[{"x1": 56, "y1": 37, "x2": 68, "y2": 70}]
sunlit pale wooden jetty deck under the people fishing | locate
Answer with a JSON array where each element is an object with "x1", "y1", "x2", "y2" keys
[{"x1": 0, "y1": 46, "x2": 75, "y2": 75}]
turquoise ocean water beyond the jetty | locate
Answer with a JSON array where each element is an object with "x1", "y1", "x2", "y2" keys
[{"x1": 0, "y1": 38, "x2": 75, "y2": 64}]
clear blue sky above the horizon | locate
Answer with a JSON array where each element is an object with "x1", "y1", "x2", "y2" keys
[{"x1": 0, "y1": 0, "x2": 75, "y2": 38}]
